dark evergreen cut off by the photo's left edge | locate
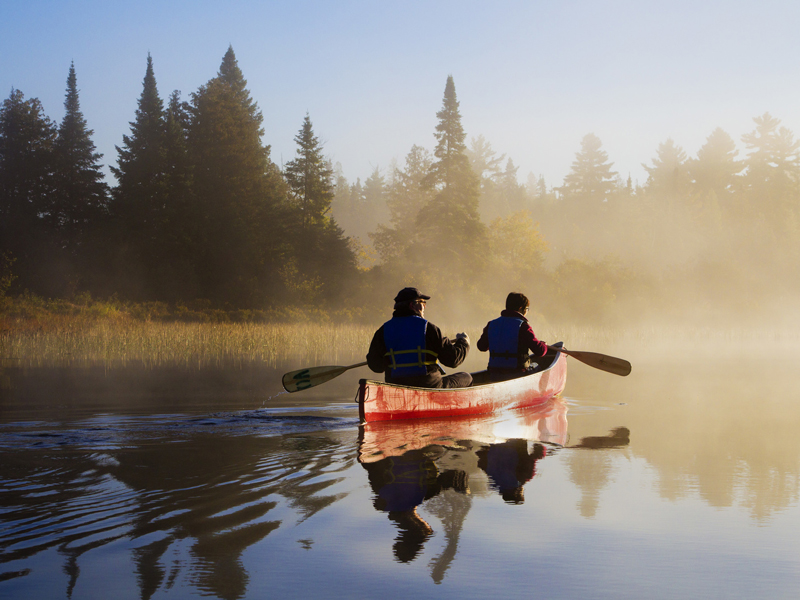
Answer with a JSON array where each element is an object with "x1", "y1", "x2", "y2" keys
[{"x1": 0, "y1": 89, "x2": 57, "y2": 291}]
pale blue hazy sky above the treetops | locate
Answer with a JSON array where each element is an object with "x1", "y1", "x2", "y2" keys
[{"x1": 0, "y1": 0, "x2": 800, "y2": 186}]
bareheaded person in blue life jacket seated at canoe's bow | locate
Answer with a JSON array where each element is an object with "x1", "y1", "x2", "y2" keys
[{"x1": 478, "y1": 292, "x2": 548, "y2": 381}]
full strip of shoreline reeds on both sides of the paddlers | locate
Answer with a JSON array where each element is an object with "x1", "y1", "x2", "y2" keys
[{"x1": 0, "y1": 319, "x2": 800, "y2": 369}]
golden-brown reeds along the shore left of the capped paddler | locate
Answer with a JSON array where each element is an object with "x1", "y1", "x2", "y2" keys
[{"x1": 0, "y1": 321, "x2": 373, "y2": 369}]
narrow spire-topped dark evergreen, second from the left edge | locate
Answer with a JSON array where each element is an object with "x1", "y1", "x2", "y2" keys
[{"x1": 47, "y1": 64, "x2": 108, "y2": 257}]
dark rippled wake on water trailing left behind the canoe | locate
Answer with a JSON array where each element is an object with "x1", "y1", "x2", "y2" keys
[{"x1": 0, "y1": 407, "x2": 357, "y2": 584}]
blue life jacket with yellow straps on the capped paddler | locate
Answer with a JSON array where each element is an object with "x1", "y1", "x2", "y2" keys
[{"x1": 383, "y1": 316, "x2": 438, "y2": 377}]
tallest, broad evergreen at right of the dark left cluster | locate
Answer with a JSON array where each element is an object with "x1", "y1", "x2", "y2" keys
[{"x1": 187, "y1": 48, "x2": 287, "y2": 306}]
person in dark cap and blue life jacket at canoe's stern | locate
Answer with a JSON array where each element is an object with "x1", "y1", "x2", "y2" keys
[{"x1": 367, "y1": 287, "x2": 472, "y2": 388}]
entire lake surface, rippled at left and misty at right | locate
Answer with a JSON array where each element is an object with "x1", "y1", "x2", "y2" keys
[{"x1": 0, "y1": 347, "x2": 800, "y2": 600}]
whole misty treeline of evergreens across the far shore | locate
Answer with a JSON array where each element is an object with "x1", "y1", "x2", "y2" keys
[{"x1": 0, "y1": 48, "x2": 800, "y2": 323}]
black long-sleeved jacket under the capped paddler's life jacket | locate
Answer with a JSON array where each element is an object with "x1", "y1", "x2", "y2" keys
[{"x1": 367, "y1": 308, "x2": 469, "y2": 387}]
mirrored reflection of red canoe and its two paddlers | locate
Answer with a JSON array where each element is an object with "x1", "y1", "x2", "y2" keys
[{"x1": 359, "y1": 398, "x2": 567, "y2": 582}]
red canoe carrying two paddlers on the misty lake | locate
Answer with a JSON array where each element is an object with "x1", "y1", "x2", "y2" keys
[{"x1": 358, "y1": 342, "x2": 567, "y2": 423}]
